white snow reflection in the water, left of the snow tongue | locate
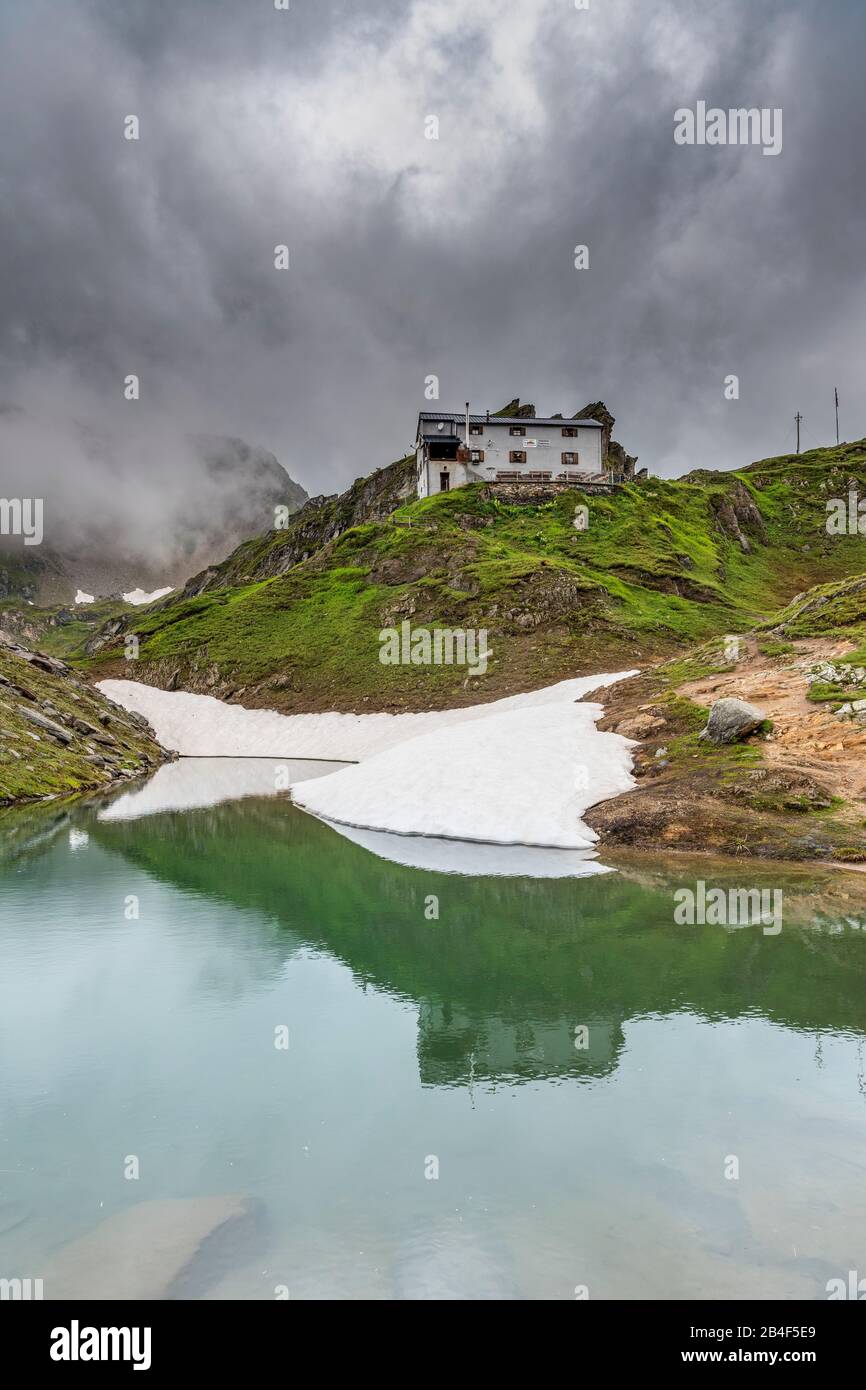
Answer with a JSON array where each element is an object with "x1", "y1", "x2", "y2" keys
[{"x1": 99, "y1": 758, "x2": 341, "y2": 820}]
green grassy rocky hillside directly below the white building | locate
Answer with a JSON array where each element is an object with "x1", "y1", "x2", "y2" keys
[{"x1": 75, "y1": 441, "x2": 866, "y2": 709}]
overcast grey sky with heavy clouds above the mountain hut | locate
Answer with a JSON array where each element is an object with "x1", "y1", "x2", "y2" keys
[{"x1": 0, "y1": 0, "x2": 866, "y2": 508}]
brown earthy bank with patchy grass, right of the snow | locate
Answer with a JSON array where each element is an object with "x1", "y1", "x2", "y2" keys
[{"x1": 584, "y1": 638, "x2": 866, "y2": 865}]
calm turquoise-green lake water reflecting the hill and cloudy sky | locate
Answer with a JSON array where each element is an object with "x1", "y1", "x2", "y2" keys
[{"x1": 0, "y1": 763, "x2": 866, "y2": 1298}]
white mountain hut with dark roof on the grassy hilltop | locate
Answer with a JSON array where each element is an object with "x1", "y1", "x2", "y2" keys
[{"x1": 416, "y1": 410, "x2": 614, "y2": 498}]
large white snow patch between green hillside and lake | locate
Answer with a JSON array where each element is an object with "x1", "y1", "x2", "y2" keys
[{"x1": 99, "y1": 671, "x2": 634, "y2": 851}]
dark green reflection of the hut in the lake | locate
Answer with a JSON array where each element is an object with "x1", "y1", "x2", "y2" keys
[{"x1": 418, "y1": 999, "x2": 623, "y2": 1086}]
